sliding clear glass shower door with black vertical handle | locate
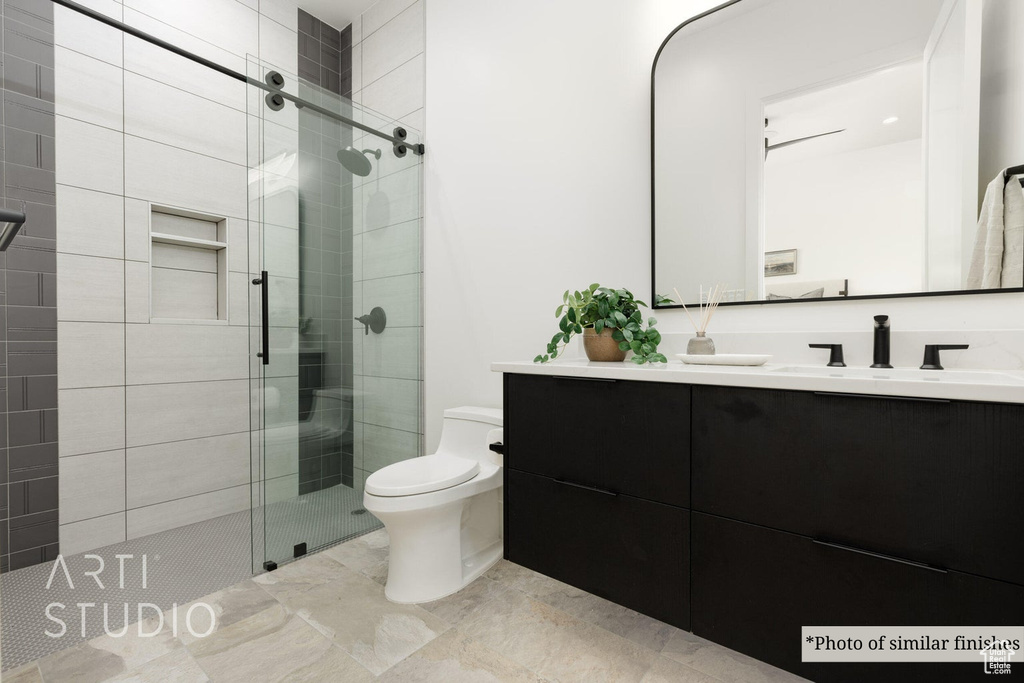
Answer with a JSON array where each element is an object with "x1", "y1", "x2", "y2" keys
[{"x1": 250, "y1": 62, "x2": 422, "y2": 566}]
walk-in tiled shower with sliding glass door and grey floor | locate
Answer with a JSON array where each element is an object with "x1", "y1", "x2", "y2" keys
[{"x1": 0, "y1": 0, "x2": 424, "y2": 670}]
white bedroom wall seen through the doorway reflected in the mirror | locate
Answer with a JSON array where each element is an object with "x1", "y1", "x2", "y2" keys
[{"x1": 765, "y1": 138, "x2": 925, "y2": 296}]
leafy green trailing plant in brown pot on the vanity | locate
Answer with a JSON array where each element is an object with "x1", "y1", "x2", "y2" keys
[{"x1": 534, "y1": 283, "x2": 672, "y2": 365}]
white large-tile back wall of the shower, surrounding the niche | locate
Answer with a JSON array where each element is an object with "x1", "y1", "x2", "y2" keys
[{"x1": 55, "y1": 0, "x2": 298, "y2": 553}]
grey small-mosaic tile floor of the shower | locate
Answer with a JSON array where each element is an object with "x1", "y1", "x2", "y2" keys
[{"x1": 0, "y1": 486, "x2": 381, "y2": 681}]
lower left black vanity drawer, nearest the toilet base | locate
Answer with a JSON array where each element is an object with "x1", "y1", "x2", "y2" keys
[{"x1": 505, "y1": 470, "x2": 690, "y2": 629}]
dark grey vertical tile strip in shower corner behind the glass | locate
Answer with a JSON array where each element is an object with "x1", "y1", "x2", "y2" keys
[{"x1": 298, "y1": 9, "x2": 359, "y2": 494}]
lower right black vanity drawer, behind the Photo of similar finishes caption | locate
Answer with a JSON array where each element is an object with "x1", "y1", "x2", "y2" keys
[{"x1": 691, "y1": 512, "x2": 1024, "y2": 683}]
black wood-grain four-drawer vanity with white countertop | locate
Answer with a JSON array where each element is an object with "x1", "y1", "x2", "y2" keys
[{"x1": 493, "y1": 361, "x2": 1024, "y2": 682}]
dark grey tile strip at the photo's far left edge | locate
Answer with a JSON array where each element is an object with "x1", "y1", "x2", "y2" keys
[{"x1": 0, "y1": 0, "x2": 58, "y2": 571}]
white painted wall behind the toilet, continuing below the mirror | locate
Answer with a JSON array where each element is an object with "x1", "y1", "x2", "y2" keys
[{"x1": 424, "y1": 0, "x2": 1024, "y2": 451}]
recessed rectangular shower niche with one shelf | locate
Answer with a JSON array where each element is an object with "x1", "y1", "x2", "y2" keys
[{"x1": 150, "y1": 205, "x2": 228, "y2": 325}]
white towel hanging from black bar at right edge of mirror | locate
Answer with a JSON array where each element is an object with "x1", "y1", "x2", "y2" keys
[{"x1": 967, "y1": 172, "x2": 1024, "y2": 290}]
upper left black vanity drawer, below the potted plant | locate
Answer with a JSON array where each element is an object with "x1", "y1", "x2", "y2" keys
[{"x1": 505, "y1": 374, "x2": 690, "y2": 507}]
